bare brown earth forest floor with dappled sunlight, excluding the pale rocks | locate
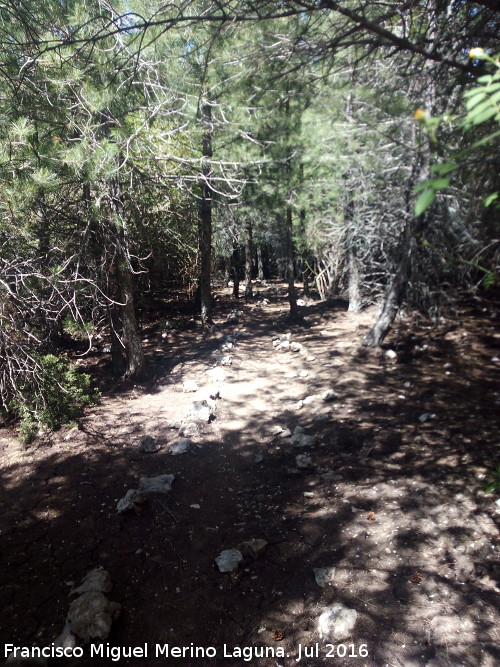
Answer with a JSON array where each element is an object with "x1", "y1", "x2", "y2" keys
[{"x1": 0, "y1": 285, "x2": 500, "y2": 667}]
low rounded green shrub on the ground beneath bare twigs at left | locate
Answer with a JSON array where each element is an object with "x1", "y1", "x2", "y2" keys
[{"x1": 14, "y1": 354, "x2": 99, "y2": 442}]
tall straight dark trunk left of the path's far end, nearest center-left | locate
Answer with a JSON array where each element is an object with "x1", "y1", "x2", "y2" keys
[{"x1": 198, "y1": 104, "x2": 213, "y2": 333}]
